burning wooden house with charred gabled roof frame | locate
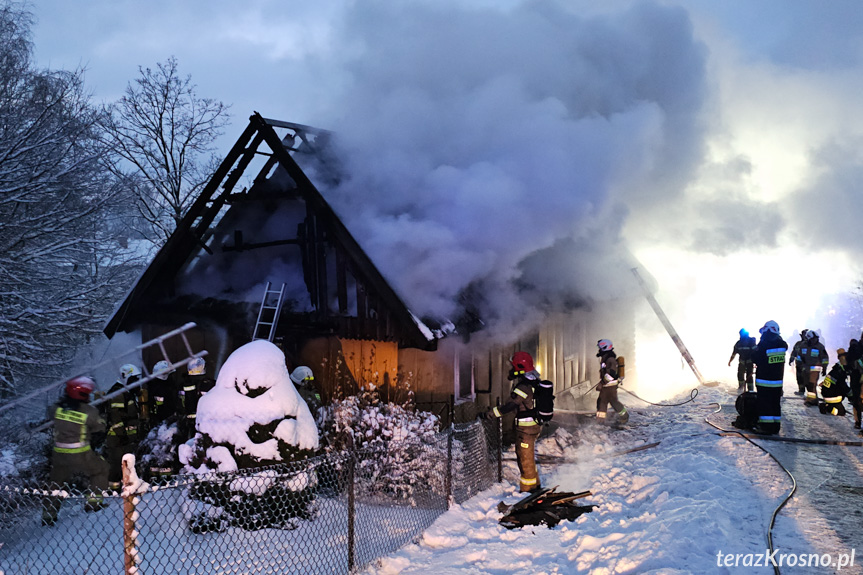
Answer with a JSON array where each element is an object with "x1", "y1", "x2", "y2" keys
[{"x1": 104, "y1": 113, "x2": 648, "y2": 426}]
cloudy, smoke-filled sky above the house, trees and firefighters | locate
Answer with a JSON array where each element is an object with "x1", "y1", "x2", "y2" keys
[{"x1": 33, "y1": 0, "x2": 863, "y2": 366}]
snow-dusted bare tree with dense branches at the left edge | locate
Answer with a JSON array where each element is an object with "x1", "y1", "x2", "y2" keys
[{"x1": 0, "y1": 0, "x2": 136, "y2": 395}]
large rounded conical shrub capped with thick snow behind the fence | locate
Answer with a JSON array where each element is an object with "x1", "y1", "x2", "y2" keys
[{"x1": 178, "y1": 340, "x2": 318, "y2": 531}]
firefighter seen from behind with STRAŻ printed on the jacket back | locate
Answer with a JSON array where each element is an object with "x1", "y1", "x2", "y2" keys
[{"x1": 752, "y1": 320, "x2": 788, "y2": 435}]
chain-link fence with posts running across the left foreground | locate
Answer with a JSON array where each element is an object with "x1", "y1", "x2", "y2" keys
[{"x1": 0, "y1": 422, "x2": 501, "y2": 575}]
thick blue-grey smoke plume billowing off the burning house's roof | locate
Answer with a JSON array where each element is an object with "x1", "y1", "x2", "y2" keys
[{"x1": 310, "y1": 2, "x2": 706, "y2": 340}]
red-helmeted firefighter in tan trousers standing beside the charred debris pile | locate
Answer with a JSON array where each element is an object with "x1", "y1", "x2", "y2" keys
[{"x1": 479, "y1": 351, "x2": 542, "y2": 492}]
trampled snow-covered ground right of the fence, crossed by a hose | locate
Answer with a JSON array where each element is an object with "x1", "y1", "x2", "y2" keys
[{"x1": 364, "y1": 383, "x2": 863, "y2": 575}]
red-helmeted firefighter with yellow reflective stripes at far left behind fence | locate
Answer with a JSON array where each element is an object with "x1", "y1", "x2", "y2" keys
[{"x1": 42, "y1": 376, "x2": 108, "y2": 526}]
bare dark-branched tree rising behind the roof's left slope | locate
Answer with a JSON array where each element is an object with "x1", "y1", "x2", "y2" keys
[{"x1": 98, "y1": 57, "x2": 229, "y2": 247}]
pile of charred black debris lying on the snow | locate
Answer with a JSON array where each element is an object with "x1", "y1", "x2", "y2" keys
[{"x1": 497, "y1": 486, "x2": 594, "y2": 529}]
